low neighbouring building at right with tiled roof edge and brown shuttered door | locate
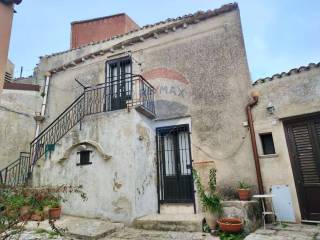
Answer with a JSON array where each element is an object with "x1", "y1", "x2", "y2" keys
[{"x1": 253, "y1": 63, "x2": 320, "y2": 221}]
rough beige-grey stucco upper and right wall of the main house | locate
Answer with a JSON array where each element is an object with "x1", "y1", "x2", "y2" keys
[{"x1": 38, "y1": 7, "x2": 256, "y2": 199}]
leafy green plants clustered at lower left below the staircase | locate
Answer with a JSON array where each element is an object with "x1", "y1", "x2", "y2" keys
[{"x1": 0, "y1": 185, "x2": 87, "y2": 240}]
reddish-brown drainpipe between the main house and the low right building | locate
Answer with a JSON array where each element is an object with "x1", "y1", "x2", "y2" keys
[{"x1": 246, "y1": 92, "x2": 264, "y2": 194}]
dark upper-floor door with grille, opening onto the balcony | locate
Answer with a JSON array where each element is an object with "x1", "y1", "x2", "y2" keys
[{"x1": 106, "y1": 58, "x2": 132, "y2": 111}]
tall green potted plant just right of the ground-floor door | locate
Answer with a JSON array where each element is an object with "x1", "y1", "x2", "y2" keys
[{"x1": 193, "y1": 168, "x2": 222, "y2": 214}]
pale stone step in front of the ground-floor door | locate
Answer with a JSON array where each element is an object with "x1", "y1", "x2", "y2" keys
[{"x1": 134, "y1": 214, "x2": 203, "y2": 232}]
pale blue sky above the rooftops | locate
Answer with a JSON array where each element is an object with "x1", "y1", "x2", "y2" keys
[{"x1": 9, "y1": 0, "x2": 320, "y2": 81}]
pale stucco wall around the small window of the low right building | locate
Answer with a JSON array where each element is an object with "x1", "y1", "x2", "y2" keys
[{"x1": 253, "y1": 64, "x2": 320, "y2": 221}]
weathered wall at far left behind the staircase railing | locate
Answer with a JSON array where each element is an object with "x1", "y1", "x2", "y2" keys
[{"x1": 0, "y1": 89, "x2": 42, "y2": 169}]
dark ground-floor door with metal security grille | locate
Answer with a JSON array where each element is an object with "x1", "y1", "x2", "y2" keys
[{"x1": 157, "y1": 125, "x2": 194, "y2": 203}]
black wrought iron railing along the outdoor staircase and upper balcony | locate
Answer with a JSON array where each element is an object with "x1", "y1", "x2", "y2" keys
[{"x1": 0, "y1": 74, "x2": 155, "y2": 185}]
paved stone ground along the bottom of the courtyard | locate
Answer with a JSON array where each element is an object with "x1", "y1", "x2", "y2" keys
[{"x1": 8, "y1": 217, "x2": 320, "y2": 240}]
